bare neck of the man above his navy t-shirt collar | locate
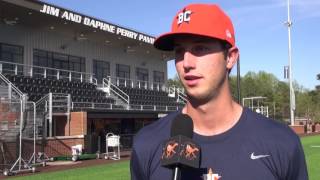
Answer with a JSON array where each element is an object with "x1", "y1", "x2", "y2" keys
[{"x1": 183, "y1": 87, "x2": 242, "y2": 136}]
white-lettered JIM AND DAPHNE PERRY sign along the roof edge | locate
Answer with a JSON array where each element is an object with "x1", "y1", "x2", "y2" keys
[{"x1": 40, "y1": 4, "x2": 155, "y2": 44}]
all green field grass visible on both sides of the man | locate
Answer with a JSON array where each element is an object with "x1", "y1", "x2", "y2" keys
[{"x1": 10, "y1": 135, "x2": 320, "y2": 180}]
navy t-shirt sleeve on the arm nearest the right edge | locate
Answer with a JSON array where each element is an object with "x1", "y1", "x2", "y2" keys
[{"x1": 286, "y1": 138, "x2": 309, "y2": 180}]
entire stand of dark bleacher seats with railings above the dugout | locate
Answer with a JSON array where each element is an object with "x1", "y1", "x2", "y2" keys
[{"x1": 0, "y1": 61, "x2": 184, "y2": 111}]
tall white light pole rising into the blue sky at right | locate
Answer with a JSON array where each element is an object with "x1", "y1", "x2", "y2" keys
[{"x1": 286, "y1": 0, "x2": 295, "y2": 125}]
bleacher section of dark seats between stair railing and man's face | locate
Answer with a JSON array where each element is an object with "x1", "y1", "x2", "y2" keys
[{"x1": 103, "y1": 77, "x2": 185, "y2": 111}]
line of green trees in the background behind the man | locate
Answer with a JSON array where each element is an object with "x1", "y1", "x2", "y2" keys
[{"x1": 168, "y1": 71, "x2": 320, "y2": 122}]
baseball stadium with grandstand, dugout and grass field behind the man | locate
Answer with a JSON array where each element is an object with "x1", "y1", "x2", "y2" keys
[{"x1": 0, "y1": 0, "x2": 320, "y2": 180}]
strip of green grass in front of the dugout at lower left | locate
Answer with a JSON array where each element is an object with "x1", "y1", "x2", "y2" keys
[{"x1": 10, "y1": 161, "x2": 130, "y2": 180}]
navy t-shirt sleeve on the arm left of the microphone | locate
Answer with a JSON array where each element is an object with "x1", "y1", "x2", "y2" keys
[{"x1": 130, "y1": 148, "x2": 147, "y2": 180}]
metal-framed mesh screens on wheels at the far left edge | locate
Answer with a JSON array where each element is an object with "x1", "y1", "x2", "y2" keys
[{"x1": 0, "y1": 100, "x2": 37, "y2": 175}]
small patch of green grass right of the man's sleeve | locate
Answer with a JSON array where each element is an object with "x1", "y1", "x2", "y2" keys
[{"x1": 301, "y1": 135, "x2": 320, "y2": 180}]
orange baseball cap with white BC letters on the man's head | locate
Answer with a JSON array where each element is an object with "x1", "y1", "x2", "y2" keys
[{"x1": 153, "y1": 4, "x2": 235, "y2": 51}]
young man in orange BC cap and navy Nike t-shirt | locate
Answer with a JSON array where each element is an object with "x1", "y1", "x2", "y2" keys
[{"x1": 131, "y1": 4, "x2": 308, "y2": 180}]
